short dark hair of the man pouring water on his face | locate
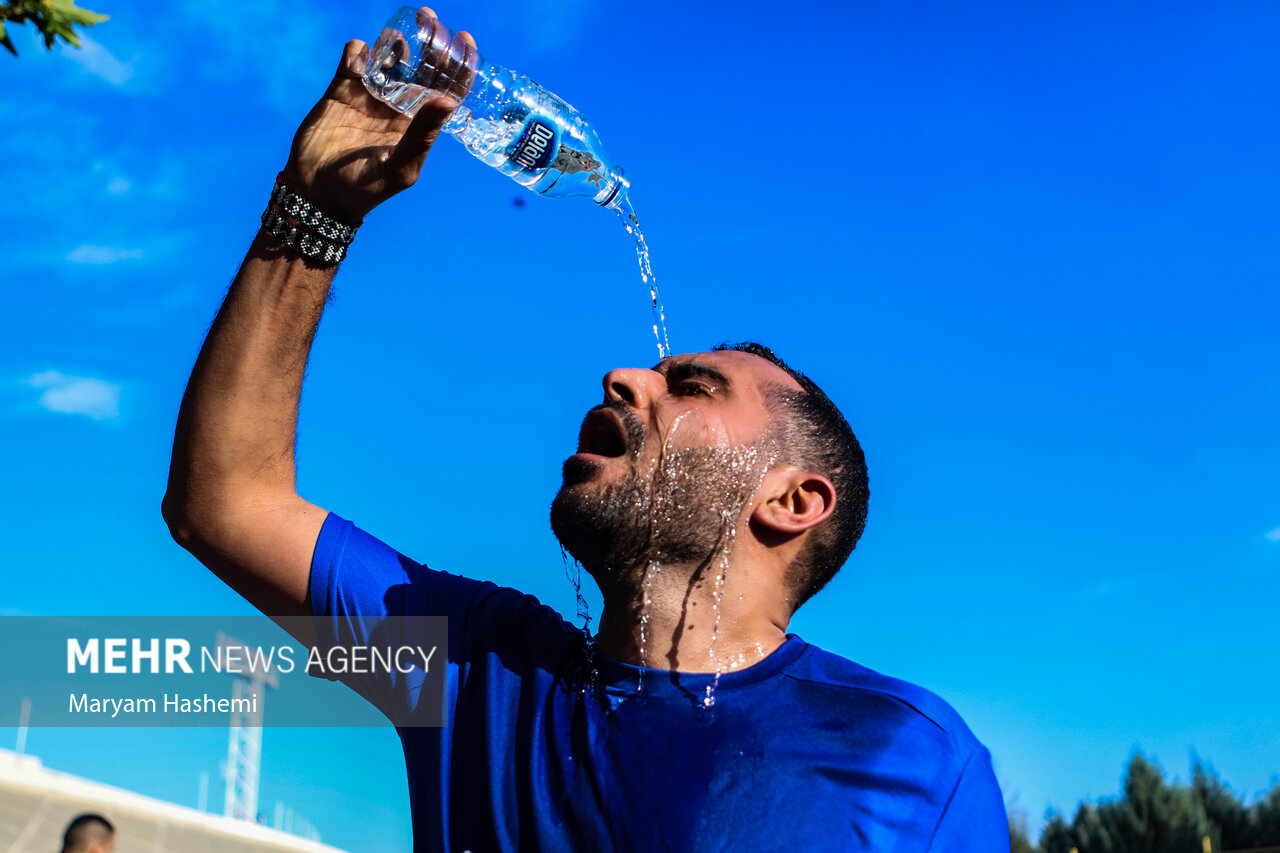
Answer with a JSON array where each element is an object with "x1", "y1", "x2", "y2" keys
[{"x1": 716, "y1": 341, "x2": 870, "y2": 610}]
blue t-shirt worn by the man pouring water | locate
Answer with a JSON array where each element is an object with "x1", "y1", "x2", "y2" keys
[{"x1": 311, "y1": 515, "x2": 1009, "y2": 853}]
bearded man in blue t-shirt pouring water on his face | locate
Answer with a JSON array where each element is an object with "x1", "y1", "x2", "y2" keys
[{"x1": 164, "y1": 10, "x2": 1009, "y2": 852}]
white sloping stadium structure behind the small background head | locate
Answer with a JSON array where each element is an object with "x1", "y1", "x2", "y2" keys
[{"x1": 0, "y1": 749, "x2": 342, "y2": 853}]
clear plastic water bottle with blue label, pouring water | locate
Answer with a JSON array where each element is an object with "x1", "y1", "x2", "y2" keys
[{"x1": 364, "y1": 6, "x2": 634, "y2": 207}]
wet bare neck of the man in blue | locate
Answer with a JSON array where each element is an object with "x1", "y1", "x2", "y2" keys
[{"x1": 596, "y1": 561, "x2": 787, "y2": 672}]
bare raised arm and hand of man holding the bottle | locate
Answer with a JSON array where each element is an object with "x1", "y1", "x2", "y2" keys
[{"x1": 163, "y1": 26, "x2": 474, "y2": 625}]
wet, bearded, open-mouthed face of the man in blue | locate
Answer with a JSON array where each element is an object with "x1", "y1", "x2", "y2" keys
[{"x1": 552, "y1": 351, "x2": 800, "y2": 578}]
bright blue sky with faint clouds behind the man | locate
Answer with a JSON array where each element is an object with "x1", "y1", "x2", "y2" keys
[{"x1": 0, "y1": 0, "x2": 1280, "y2": 850}]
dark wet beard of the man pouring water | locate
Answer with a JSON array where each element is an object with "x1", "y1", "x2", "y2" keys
[{"x1": 550, "y1": 403, "x2": 768, "y2": 583}]
